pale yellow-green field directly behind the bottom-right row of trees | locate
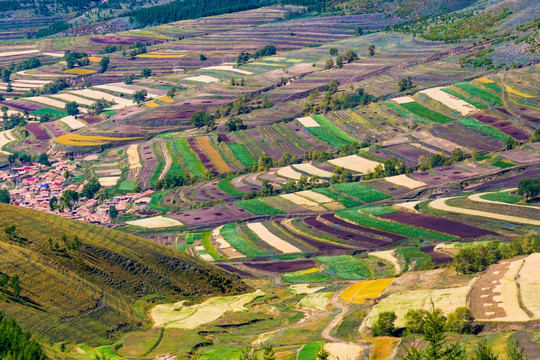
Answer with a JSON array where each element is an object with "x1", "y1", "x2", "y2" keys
[{"x1": 361, "y1": 278, "x2": 476, "y2": 328}]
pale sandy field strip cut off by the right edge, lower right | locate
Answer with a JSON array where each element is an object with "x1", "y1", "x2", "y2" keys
[{"x1": 519, "y1": 253, "x2": 540, "y2": 319}]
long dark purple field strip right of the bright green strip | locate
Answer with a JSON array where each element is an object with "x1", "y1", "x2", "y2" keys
[{"x1": 381, "y1": 212, "x2": 498, "y2": 238}]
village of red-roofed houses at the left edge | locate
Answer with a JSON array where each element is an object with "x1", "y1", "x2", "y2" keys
[{"x1": 0, "y1": 161, "x2": 153, "y2": 224}]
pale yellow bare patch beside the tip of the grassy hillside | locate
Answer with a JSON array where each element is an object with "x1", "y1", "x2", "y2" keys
[{"x1": 150, "y1": 289, "x2": 264, "y2": 329}]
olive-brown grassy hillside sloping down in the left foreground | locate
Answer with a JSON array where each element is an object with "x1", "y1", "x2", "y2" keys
[{"x1": 0, "y1": 204, "x2": 247, "y2": 343}]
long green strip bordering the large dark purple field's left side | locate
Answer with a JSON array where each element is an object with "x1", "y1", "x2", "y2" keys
[{"x1": 337, "y1": 209, "x2": 452, "y2": 240}]
